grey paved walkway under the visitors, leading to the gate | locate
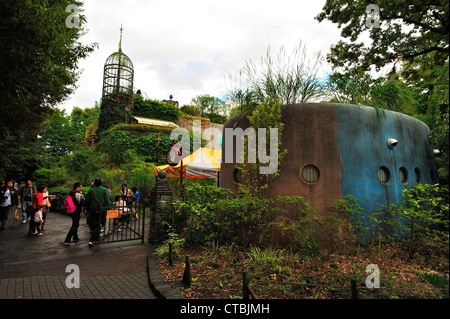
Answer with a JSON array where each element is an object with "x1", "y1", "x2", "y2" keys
[{"x1": 0, "y1": 213, "x2": 156, "y2": 299}]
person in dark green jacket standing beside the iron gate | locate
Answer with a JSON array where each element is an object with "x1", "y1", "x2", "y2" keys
[{"x1": 86, "y1": 177, "x2": 111, "y2": 248}]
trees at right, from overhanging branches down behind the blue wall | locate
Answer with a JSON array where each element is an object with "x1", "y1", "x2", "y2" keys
[{"x1": 316, "y1": 0, "x2": 449, "y2": 183}]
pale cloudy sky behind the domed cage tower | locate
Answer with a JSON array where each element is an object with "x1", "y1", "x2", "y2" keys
[{"x1": 58, "y1": 0, "x2": 340, "y2": 113}]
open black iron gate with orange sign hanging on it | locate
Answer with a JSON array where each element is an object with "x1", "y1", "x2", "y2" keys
[{"x1": 99, "y1": 205, "x2": 149, "y2": 243}]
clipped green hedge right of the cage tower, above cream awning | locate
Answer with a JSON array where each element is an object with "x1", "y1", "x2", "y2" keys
[{"x1": 133, "y1": 95, "x2": 181, "y2": 122}]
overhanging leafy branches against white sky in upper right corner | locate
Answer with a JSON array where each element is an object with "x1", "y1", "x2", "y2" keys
[{"x1": 316, "y1": 0, "x2": 449, "y2": 71}]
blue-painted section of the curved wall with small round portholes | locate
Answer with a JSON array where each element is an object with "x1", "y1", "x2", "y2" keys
[{"x1": 333, "y1": 104, "x2": 437, "y2": 226}]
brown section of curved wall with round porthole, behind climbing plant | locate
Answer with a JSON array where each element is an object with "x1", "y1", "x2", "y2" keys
[{"x1": 219, "y1": 103, "x2": 342, "y2": 219}]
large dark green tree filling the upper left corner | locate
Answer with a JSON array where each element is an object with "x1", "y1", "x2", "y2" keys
[{"x1": 0, "y1": 0, "x2": 96, "y2": 139}]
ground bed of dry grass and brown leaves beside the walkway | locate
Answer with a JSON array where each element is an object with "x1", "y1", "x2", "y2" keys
[{"x1": 156, "y1": 243, "x2": 449, "y2": 299}]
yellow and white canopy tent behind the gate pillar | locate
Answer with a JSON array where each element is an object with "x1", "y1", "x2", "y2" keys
[{"x1": 155, "y1": 147, "x2": 222, "y2": 178}]
